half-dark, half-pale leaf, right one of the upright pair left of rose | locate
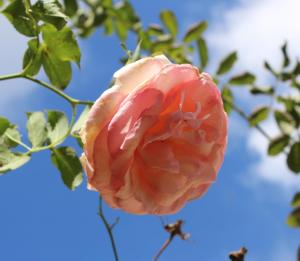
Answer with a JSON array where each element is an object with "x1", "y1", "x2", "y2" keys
[{"x1": 48, "y1": 111, "x2": 69, "y2": 143}]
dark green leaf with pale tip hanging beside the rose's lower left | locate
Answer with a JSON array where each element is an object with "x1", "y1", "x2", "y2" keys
[{"x1": 51, "y1": 147, "x2": 83, "y2": 190}]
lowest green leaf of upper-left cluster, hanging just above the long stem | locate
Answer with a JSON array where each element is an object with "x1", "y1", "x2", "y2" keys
[{"x1": 42, "y1": 50, "x2": 72, "y2": 89}]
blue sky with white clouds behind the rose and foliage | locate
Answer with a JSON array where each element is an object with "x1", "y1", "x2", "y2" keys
[{"x1": 0, "y1": 0, "x2": 300, "y2": 261}]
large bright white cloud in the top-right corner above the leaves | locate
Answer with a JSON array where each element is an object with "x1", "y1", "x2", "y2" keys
[{"x1": 208, "y1": 0, "x2": 300, "y2": 75}]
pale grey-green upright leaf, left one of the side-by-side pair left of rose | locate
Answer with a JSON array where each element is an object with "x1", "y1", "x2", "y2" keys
[{"x1": 27, "y1": 111, "x2": 47, "y2": 148}]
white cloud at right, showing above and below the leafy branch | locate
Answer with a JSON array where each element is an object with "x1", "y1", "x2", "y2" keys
[{"x1": 207, "y1": 0, "x2": 300, "y2": 191}]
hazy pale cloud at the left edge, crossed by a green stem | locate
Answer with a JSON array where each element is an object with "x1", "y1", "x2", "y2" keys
[{"x1": 0, "y1": 15, "x2": 35, "y2": 121}]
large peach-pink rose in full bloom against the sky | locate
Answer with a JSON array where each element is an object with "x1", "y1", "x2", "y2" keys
[{"x1": 81, "y1": 55, "x2": 227, "y2": 214}]
